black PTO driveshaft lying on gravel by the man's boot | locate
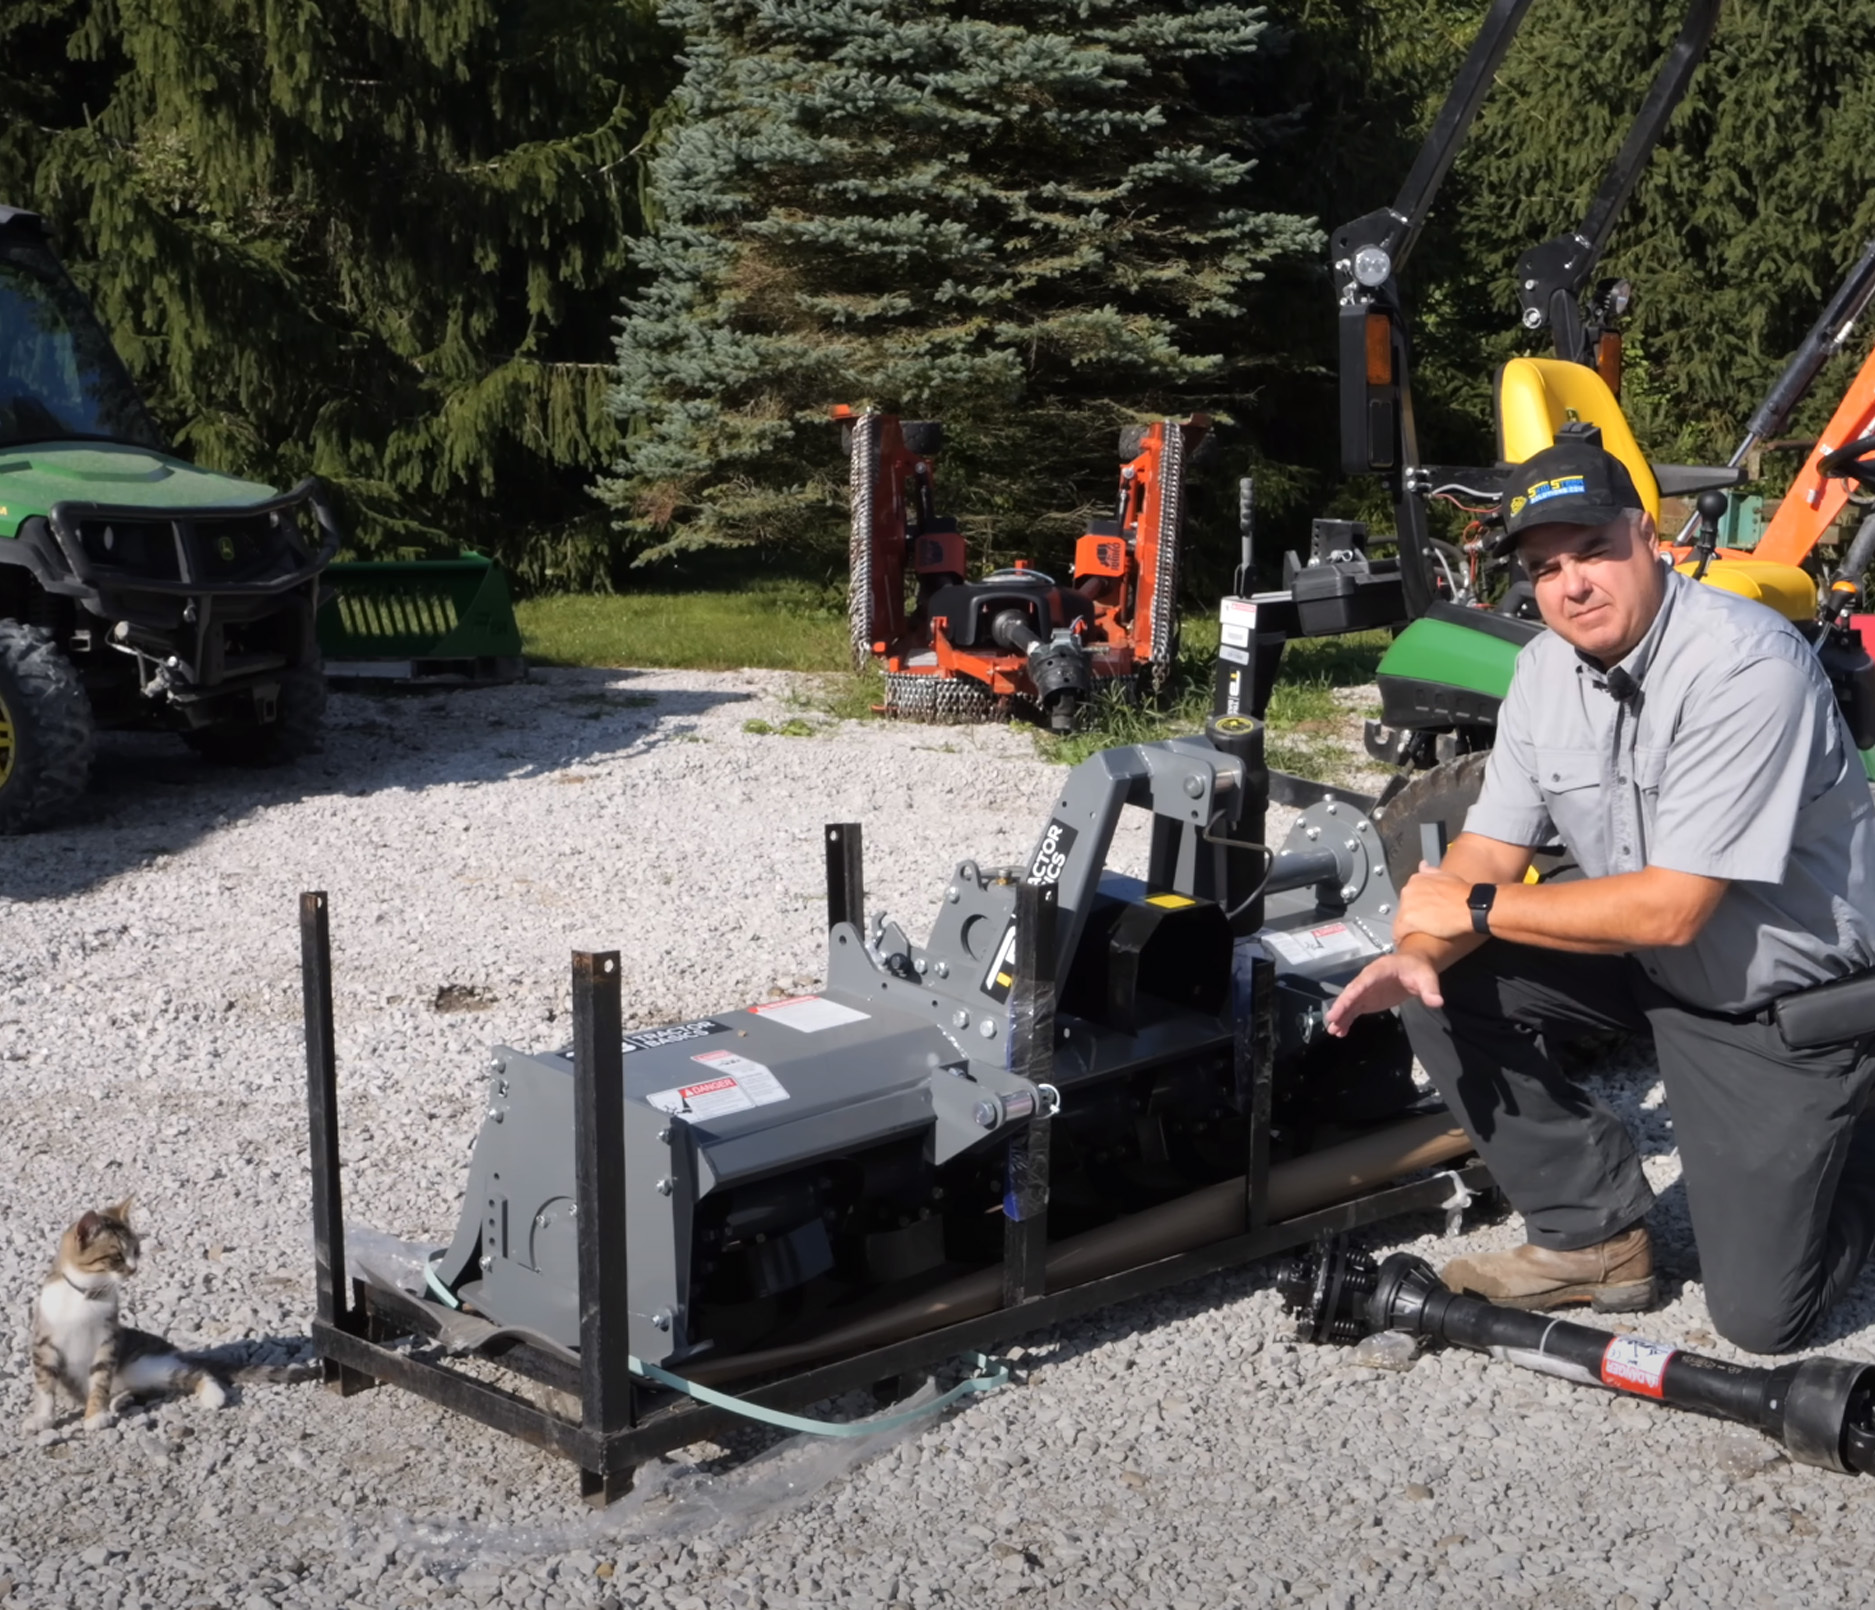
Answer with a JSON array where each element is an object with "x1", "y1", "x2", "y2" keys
[{"x1": 1277, "y1": 1237, "x2": 1875, "y2": 1473}]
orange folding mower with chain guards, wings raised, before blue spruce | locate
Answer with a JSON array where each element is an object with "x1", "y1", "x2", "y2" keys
[{"x1": 834, "y1": 407, "x2": 1211, "y2": 733}]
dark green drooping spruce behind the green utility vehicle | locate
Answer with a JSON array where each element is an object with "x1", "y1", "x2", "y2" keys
[{"x1": 0, "y1": 0, "x2": 669, "y2": 579}]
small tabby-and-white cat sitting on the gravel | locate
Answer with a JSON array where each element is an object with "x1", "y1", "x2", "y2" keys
[{"x1": 26, "y1": 1198, "x2": 301, "y2": 1432}]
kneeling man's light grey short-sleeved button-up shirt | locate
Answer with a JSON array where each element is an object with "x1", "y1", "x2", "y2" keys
[{"x1": 1464, "y1": 572, "x2": 1875, "y2": 1012}]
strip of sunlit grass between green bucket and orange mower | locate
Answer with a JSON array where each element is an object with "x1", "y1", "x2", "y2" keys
[{"x1": 514, "y1": 577, "x2": 848, "y2": 671}]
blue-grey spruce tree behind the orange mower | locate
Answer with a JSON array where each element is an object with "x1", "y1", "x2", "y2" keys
[{"x1": 608, "y1": 0, "x2": 1320, "y2": 559}]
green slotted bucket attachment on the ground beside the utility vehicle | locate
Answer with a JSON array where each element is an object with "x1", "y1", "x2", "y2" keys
[{"x1": 319, "y1": 553, "x2": 527, "y2": 682}]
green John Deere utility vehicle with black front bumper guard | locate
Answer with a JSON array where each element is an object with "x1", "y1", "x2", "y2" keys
[{"x1": 0, "y1": 206, "x2": 339, "y2": 834}]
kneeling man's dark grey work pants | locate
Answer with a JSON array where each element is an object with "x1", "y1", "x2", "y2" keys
[{"x1": 1403, "y1": 939, "x2": 1875, "y2": 1353}]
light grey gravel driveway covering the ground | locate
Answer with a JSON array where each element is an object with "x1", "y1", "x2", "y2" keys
[{"x1": 0, "y1": 671, "x2": 1875, "y2": 1610}]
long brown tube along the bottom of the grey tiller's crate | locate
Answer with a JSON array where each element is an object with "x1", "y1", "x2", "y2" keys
[{"x1": 679, "y1": 1113, "x2": 1472, "y2": 1385}]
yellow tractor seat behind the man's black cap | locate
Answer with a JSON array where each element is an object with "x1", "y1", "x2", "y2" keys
[{"x1": 1498, "y1": 358, "x2": 1817, "y2": 620}]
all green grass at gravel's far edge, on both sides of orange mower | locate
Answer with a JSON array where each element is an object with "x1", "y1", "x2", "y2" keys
[{"x1": 516, "y1": 577, "x2": 1391, "y2": 782}]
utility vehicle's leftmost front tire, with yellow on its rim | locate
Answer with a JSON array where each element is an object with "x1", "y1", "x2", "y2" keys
[{"x1": 0, "y1": 620, "x2": 92, "y2": 834}]
